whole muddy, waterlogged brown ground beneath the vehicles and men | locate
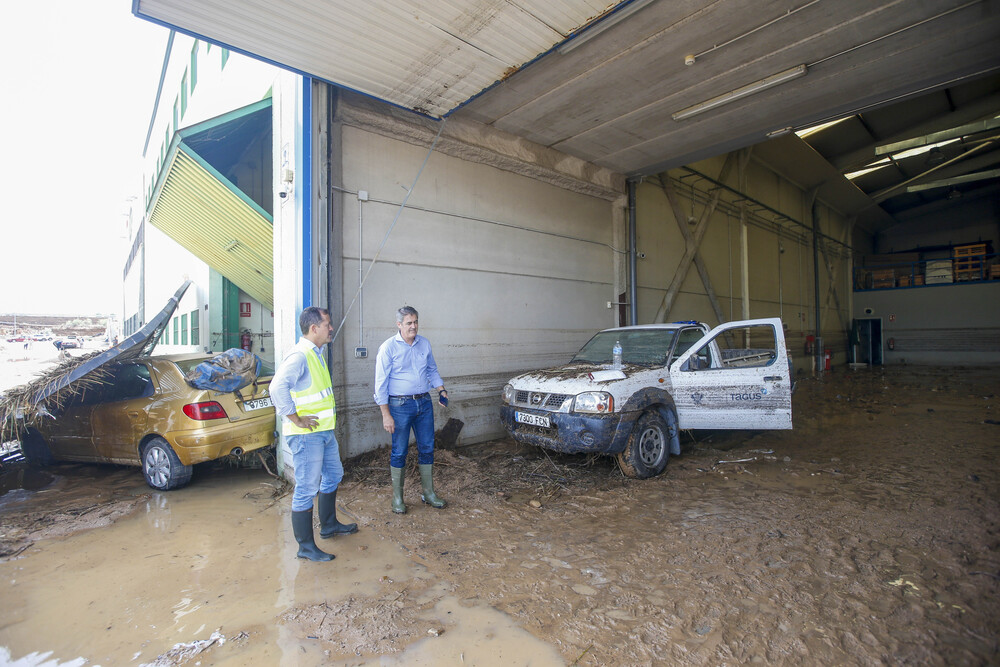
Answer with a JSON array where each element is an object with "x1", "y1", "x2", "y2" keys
[{"x1": 0, "y1": 367, "x2": 1000, "y2": 665}]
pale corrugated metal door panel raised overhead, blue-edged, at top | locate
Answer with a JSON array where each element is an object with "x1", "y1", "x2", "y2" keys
[{"x1": 133, "y1": 0, "x2": 616, "y2": 116}]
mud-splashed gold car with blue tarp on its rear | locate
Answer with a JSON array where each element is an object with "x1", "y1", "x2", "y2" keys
[{"x1": 21, "y1": 354, "x2": 275, "y2": 490}]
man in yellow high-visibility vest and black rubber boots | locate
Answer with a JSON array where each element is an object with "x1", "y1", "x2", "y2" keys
[{"x1": 270, "y1": 306, "x2": 358, "y2": 561}]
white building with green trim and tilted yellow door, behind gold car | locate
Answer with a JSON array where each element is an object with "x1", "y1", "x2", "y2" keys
[{"x1": 122, "y1": 33, "x2": 288, "y2": 366}]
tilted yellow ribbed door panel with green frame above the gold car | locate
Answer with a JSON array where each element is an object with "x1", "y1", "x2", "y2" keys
[{"x1": 149, "y1": 143, "x2": 274, "y2": 308}]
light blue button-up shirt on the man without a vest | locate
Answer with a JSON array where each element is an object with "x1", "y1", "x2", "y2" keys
[{"x1": 375, "y1": 333, "x2": 444, "y2": 405}]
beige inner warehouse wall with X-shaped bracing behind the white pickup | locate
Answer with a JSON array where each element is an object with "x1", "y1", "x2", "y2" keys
[{"x1": 636, "y1": 156, "x2": 853, "y2": 368}]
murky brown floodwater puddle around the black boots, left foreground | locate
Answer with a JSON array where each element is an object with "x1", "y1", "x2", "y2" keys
[{"x1": 0, "y1": 466, "x2": 563, "y2": 666}]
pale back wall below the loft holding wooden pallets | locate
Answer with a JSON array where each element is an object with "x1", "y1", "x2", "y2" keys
[{"x1": 854, "y1": 282, "x2": 1000, "y2": 365}]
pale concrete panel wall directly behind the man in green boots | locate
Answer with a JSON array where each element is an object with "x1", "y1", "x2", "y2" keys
[{"x1": 324, "y1": 94, "x2": 624, "y2": 456}]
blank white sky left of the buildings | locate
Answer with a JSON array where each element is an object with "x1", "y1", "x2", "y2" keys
[{"x1": 0, "y1": 0, "x2": 169, "y2": 315}]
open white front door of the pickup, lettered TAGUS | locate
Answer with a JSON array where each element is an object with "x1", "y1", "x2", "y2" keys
[{"x1": 669, "y1": 318, "x2": 793, "y2": 429}]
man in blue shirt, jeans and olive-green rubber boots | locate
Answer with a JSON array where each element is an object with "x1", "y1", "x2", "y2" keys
[{"x1": 375, "y1": 306, "x2": 448, "y2": 514}]
